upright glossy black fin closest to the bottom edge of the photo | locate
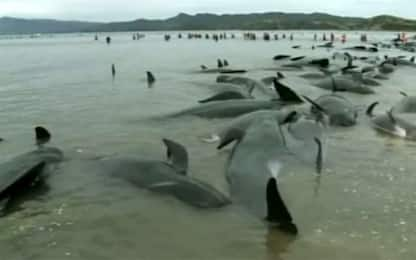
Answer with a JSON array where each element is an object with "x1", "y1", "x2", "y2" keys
[{"x1": 266, "y1": 178, "x2": 298, "y2": 235}]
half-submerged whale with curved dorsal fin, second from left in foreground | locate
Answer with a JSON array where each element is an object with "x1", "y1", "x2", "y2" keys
[{"x1": 97, "y1": 139, "x2": 230, "y2": 208}]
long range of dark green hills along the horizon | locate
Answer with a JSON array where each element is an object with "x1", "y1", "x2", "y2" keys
[{"x1": 0, "y1": 12, "x2": 416, "y2": 34}]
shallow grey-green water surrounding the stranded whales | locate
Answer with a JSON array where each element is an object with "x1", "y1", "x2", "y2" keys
[{"x1": 0, "y1": 32, "x2": 416, "y2": 260}]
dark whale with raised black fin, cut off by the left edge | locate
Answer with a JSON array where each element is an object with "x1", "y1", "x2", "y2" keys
[{"x1": 0, "y1": 127, "x2": 63, "y2": 214}]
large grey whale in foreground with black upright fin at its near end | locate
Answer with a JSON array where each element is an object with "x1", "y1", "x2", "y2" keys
[{"x1": 218, "y1": 113, "x2": 322, "y2": 234}]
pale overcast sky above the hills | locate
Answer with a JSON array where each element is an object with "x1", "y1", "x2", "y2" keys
[{"x1": 0, "y1": 0, "x2": 416, "y2": 21}]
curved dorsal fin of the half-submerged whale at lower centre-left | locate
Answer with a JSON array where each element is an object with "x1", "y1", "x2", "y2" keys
[{"x1": 163, "y1": 138, "x2": 188, "y2": 175}]
